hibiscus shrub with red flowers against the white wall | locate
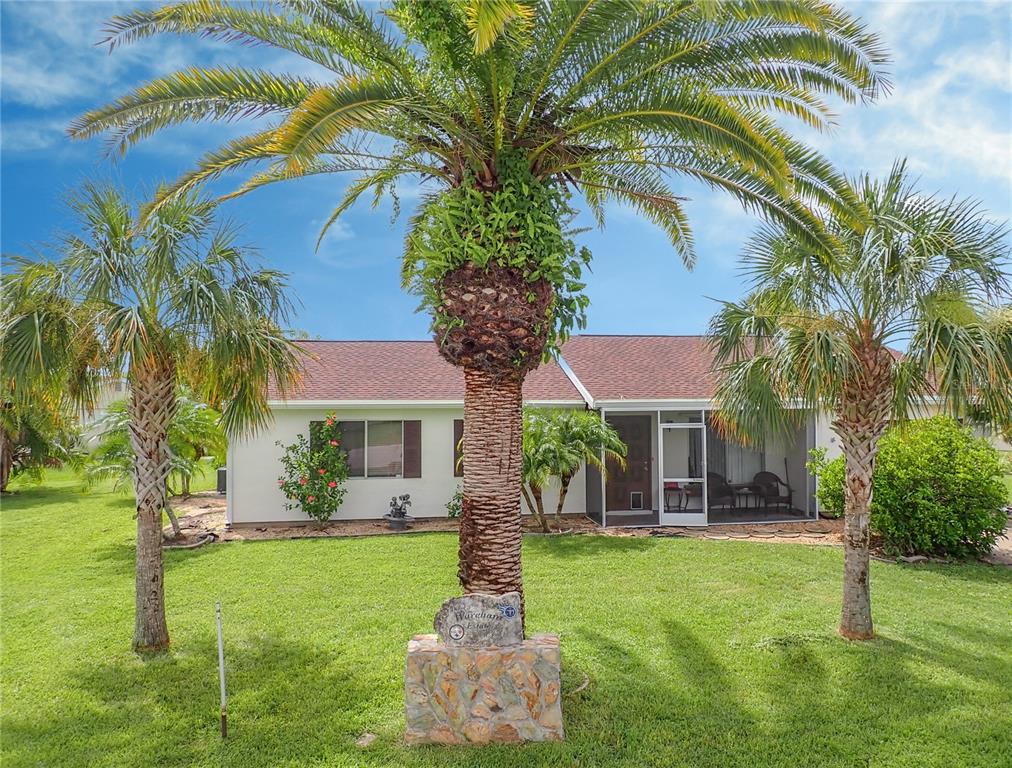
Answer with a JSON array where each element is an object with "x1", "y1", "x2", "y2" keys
[{"x1": 277, "y1": 414, "x2": 348, "y2": 523}]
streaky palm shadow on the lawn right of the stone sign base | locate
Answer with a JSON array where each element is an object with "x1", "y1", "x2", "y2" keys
[{"x1": 566, "y1": 620, "x2": 991, "y2": 768}]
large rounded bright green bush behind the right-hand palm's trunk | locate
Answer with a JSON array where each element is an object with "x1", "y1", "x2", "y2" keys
[{"x1": 810, "y1": 417, "x2": 1007, "y2": 558}]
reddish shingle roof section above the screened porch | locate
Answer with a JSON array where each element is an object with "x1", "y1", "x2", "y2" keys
[{"x1": 563, "y1": 336, "x2": 714, "y2": 401}]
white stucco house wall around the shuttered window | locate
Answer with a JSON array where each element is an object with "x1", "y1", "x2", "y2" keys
[{"x1": 228, "y1": 407, "x2": 586, "y2": 524}]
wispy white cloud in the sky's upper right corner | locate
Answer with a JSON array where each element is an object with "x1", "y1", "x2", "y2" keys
[{"x1": 813, "y1": 2, "x2": 1012, "y2": 193}]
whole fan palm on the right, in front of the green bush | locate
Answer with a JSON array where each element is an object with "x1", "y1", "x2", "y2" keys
[{"x1": 710, "y1": 163, "x2": 1012, "y2": 639}]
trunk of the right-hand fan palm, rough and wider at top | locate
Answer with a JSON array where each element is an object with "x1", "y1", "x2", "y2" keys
[{"x1": 833, "y1": 347, "x2": 893, "y2": 639}]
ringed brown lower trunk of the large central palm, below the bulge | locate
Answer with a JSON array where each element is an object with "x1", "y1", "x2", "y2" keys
[{"x1": 457, "y1": 367, "x2": 523, "y2": 616}]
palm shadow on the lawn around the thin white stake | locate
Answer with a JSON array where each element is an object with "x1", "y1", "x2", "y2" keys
[{"x1": 3, "y1": 636, "x2": 389, "y2": 768}]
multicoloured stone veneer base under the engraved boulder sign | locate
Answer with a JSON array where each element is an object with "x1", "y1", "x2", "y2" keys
[{"x1": 404, "y1": 634, "x2": 563, "y2": 745}]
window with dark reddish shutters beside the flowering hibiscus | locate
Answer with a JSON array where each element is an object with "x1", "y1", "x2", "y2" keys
[{"x1": 310, "y1": 421, "x2": 422, "y2": 478}]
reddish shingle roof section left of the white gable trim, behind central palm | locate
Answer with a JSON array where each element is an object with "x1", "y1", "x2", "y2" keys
[{"x1": 270, "y1": 341, "x2": 583, "y2": 402}]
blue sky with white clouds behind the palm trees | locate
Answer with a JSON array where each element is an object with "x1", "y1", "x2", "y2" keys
[{"x1": 0, "y1": 0, "x2": 1012, "y2": 339}]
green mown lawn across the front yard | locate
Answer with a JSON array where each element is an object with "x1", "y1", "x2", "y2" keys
[{"x1": 0, "y1": 479, "x2": 1012, "y2": 768}]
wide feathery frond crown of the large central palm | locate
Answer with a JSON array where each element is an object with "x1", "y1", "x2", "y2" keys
[{"x1": 70, "y1": 0, "x2": 886, "y2": 335}]
